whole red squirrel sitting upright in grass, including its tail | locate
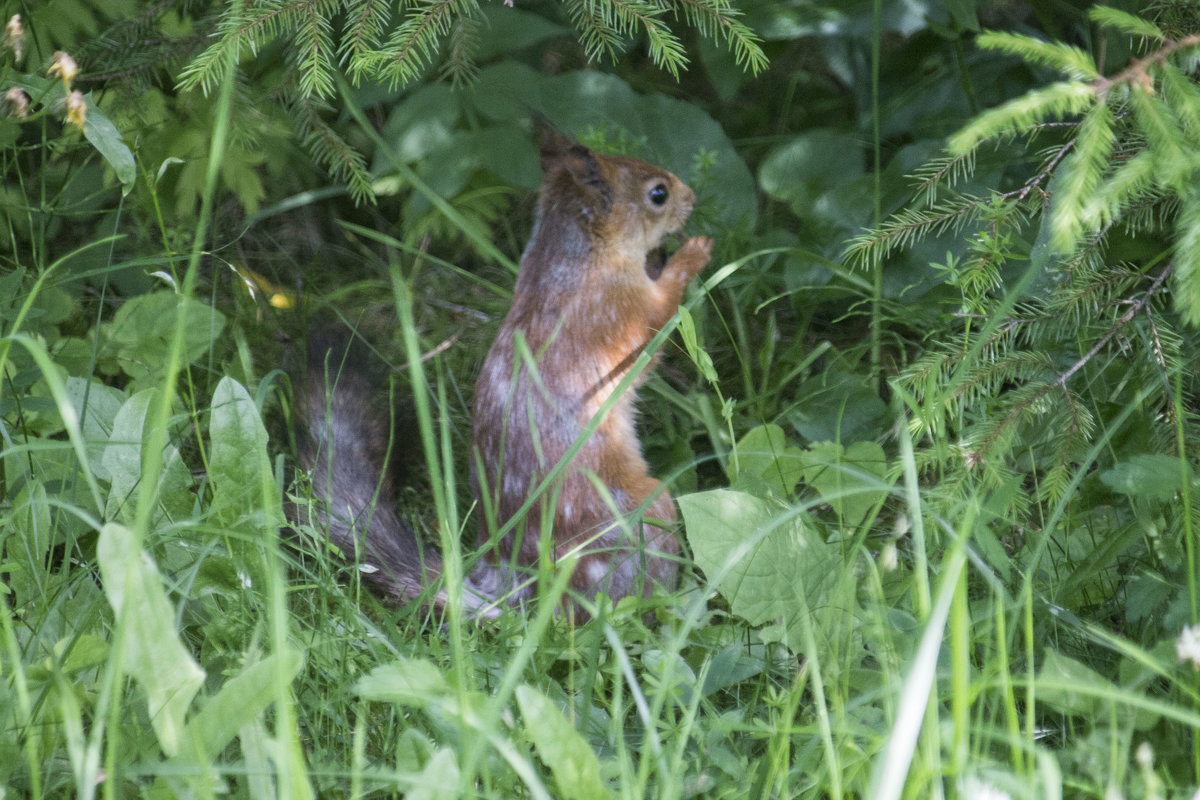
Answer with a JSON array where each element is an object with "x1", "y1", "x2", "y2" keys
[{"x1": 296, "y1": 131, "x2": 713, "y2": 616}]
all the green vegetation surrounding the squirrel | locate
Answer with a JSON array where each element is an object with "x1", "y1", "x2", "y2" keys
[{"x1": 0, "y1": 0, "x2": 1200, "y2": 800}]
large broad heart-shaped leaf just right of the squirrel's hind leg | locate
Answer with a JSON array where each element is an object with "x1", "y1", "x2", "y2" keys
[{"x1": 679, "y1": 489, "x2": 840, "y2": 651}]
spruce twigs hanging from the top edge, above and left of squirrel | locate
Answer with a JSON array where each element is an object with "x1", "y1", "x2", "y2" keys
[{"x1": 171, "y1": 0, "x2": 766, "y2": 201}]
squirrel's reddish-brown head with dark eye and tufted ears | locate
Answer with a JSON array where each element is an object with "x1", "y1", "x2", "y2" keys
[{"x1": 541, "y1": 132, "x2": 696, "y2": 254}]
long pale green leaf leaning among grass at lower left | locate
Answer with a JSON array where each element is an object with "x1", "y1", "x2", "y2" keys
[{"x1": 96, "y1": 523, "x2": 204, "y2": 756}]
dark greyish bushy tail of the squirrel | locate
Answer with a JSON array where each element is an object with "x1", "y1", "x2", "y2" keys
[{"x1": 295, "y1": 337, "x2": 445, "y2": 608}]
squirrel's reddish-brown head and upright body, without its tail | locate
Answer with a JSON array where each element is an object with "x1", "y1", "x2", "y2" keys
[{"x1": 473, "y1": 138, "x2": 712, "y2": 599}]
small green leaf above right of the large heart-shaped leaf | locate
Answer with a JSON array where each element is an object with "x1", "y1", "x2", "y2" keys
[{"x1": 803, "y1": 441, "x2": 888, "y2": 528}]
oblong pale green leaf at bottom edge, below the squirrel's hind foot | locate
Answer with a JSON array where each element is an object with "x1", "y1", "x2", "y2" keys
[{"x1": 516, "y1": 686, "x2": 612, "y2": 800}]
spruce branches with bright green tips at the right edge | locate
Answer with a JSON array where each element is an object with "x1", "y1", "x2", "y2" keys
[{"x1": 846, "y1": 8, "x2": 1200, "y2": 522}]
